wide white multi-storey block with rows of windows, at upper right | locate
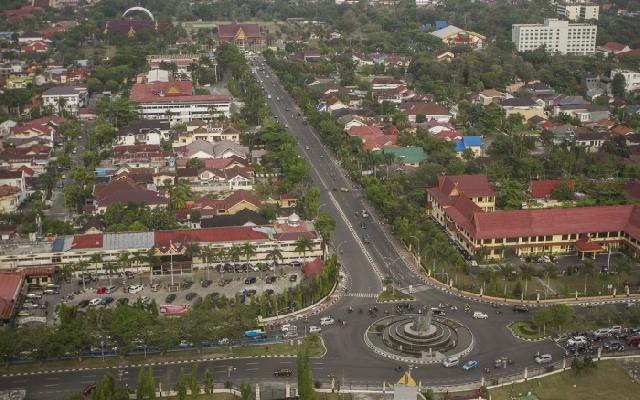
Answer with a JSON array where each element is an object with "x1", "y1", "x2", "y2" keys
[{"x1": 511, "y1": 18, "x2": 598, "y2": 55}]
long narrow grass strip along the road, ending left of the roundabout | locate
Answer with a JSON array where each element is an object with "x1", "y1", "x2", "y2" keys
[{"x1": 0, "y1": 335, "x2": 326, "y2": 374}]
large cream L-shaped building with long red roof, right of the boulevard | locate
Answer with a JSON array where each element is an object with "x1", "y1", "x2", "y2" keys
[{"x1": 426, "y1": 177, "x2": 640, "y2": 259}]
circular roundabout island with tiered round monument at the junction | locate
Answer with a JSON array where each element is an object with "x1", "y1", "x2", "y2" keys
[{"x1": 365, "y1": 310, "x2": 473, "y2": 364}]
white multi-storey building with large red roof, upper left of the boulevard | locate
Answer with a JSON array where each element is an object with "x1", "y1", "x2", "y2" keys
[{"x1": 130, "y1": 81, "x2": 231, "y2": 123}]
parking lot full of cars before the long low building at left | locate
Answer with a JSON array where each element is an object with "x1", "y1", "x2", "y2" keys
[{"x1": 18, "y1": 265, "x2": 304, "y2": 323}]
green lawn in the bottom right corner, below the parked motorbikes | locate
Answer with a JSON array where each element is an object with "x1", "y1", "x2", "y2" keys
[{"x1": 490, "y1": 361, "x2": 640, "y2": 400}]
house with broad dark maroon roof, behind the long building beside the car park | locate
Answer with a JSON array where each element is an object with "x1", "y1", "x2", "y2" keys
[{"x1": 93, "y1": 175, "x2": 169, "y2": 214}]
